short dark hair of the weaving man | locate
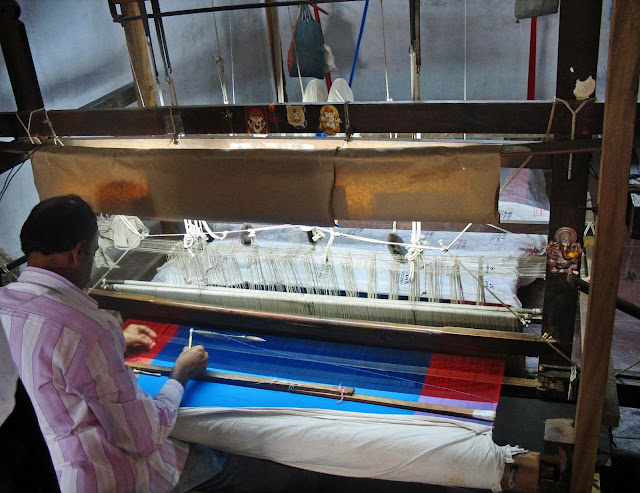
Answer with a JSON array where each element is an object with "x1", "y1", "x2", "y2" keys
[{"x1": 20, "y1": 195, "x2": 98, "y2": 255}]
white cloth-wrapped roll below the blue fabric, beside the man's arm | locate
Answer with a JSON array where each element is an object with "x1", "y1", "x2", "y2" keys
[{"x1": 172, "y1": 407, "x2": 512, "y2": 492}]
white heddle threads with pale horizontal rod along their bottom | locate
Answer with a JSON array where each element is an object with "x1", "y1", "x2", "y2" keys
[{"x1": 110, "y1": 234, "x2": 531, "y2": 331}]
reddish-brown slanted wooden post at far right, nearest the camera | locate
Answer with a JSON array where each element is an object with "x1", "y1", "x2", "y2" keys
[{"x1": 571, "y1": 0, "x2": 640, "y2": 493}]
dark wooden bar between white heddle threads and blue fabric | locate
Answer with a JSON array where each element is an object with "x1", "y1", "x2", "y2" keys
[{"x1": 90, "y1": 290, "x2": 553, "y2": 356}]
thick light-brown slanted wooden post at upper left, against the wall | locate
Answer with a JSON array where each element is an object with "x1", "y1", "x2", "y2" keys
[{"x1": 120, "y1": 3, "x2": 158, "y2": 106}]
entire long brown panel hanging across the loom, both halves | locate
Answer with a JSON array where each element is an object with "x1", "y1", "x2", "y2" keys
[{"x1": 32, "y1": 139, "x2": 500, "y2": 225}]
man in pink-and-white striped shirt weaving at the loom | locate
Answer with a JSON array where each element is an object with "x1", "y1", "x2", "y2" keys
[{"x1": 0, "y1": 195, "x2": 316, "y2": 493}]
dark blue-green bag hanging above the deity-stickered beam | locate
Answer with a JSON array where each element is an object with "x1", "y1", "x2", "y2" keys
[{"x1": 288, "y1": 5, "x2": 325, "y2": 79}]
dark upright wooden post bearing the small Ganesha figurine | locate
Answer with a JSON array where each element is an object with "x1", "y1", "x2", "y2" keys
[{"x1": 540, "y1": 0, "x2": 602, "y2": 364}]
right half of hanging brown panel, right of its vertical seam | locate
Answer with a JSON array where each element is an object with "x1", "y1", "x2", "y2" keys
[{"x1": 333, "y1": 146, "x2": 500, "y2": 223}]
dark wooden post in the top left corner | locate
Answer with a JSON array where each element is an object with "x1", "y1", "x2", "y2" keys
[{"x1": 0, "y1": 0, "x2": 44, "y2": 111}]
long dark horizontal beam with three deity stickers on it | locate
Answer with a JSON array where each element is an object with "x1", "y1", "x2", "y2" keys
[{"x1": 0, "y1": 101, "x2": 640, "y2": 137}]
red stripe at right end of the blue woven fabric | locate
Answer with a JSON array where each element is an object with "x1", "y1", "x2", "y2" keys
[{"x1": 420, "y1": 354, "x2": 504, "y2": 403}]
